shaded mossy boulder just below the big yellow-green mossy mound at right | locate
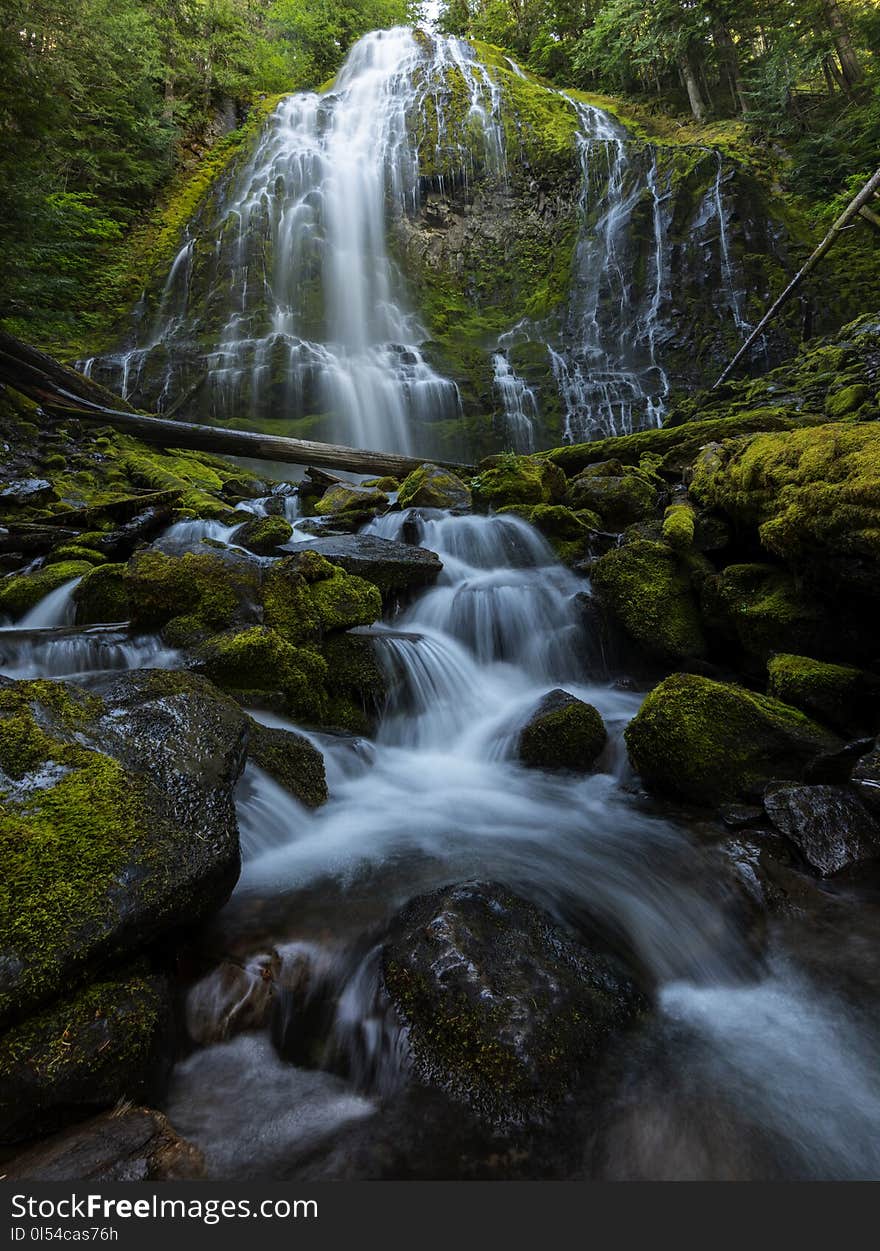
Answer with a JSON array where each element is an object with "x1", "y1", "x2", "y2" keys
[{"x1": 701, "y1": 563, "x2": 829, "y2": 661}]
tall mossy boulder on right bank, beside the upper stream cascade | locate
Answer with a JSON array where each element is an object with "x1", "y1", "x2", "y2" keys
[{"x1": 591, "y1": 539, "x2": 706, "y2": 663}]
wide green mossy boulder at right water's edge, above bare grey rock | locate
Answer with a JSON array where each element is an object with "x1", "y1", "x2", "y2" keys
[{"x1": 626, "y1": 673, "x2": 841, "y2": 806}]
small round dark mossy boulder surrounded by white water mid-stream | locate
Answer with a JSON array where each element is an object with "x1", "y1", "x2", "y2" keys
[{"x1": 517, "y1": 689, "x2": 608, "y2": 773}]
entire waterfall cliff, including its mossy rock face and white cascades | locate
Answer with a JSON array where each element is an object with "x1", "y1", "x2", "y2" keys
[{"x1": 85, "y1": 29, "x2": 789, "y2": 455}]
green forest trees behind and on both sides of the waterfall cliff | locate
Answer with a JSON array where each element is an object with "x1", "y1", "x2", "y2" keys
[{"x1": 0, "y1": 0, "x2": 880, "y2": 355}]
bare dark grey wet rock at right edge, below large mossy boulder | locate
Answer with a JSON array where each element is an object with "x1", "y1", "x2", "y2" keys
[{"x1": 764, "y1": 784, "x2": 880, "y2": 877}]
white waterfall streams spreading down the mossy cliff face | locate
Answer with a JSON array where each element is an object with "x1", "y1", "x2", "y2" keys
[{"x1": 81, "y1": 28, "x2": 761, "y2": 457}]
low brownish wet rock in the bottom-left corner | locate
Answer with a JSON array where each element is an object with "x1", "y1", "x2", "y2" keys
[{"x1": 3, "y1": 1107, "x2": 204, "y2": 1182}]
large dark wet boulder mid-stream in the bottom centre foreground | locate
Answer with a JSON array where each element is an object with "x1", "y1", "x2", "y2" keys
[{"x1": 383, "y1": 882, "x2": 646, "y2": 1122}]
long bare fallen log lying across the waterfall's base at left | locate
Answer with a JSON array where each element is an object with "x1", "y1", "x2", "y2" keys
[{"x1": 0, "y1": 332, "x2": 473, "y2": 478}]
